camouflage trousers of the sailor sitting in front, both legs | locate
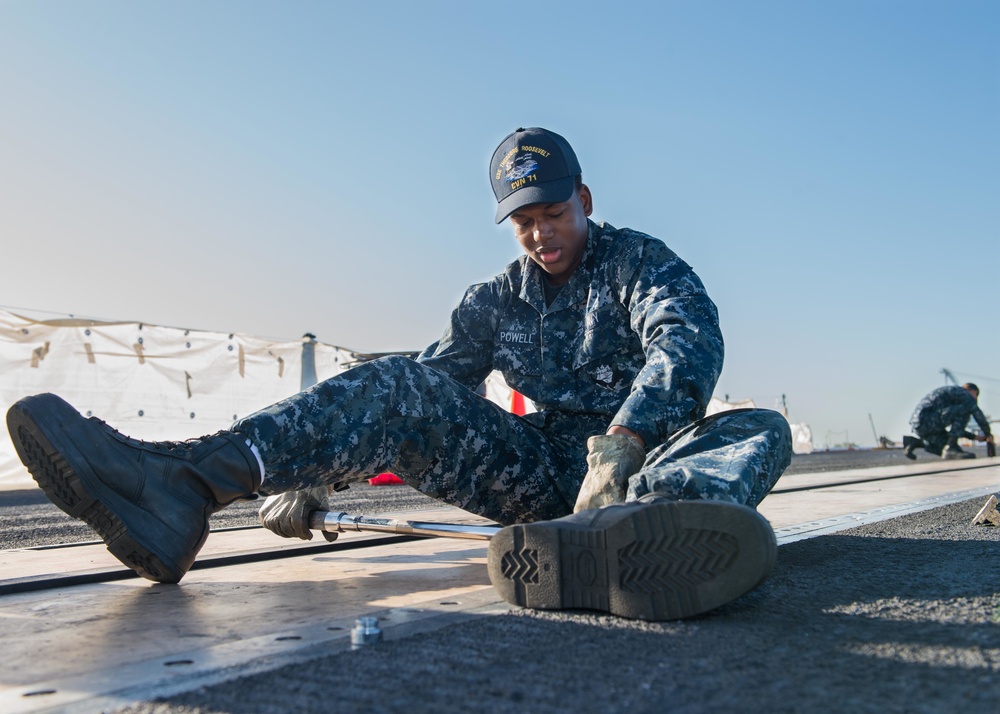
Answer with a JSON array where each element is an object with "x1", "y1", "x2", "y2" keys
[{"x1": 232, "y1": 356, "x2": 791, "y2": 524}]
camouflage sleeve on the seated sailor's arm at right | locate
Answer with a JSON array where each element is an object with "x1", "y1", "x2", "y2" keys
[{"x1": 612, "y1": 241, "x2": 725, "y2": 448}]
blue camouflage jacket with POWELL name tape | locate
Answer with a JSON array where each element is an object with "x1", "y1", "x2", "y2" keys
[{"x1": 418, "y1": 221, "x2": 724, "y2": 448}]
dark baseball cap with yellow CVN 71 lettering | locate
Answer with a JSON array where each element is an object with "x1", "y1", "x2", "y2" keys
[{"x1": 490, "y1": 126, "x2": 582, "y2": 223}]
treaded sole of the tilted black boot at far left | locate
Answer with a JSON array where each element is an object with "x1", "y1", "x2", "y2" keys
[{"x1": 7, "y1": 397, "x2": 184, "y2": 583}]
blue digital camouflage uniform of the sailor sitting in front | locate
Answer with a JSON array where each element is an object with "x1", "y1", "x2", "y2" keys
[{"x1": 233, "y1": 221, "x2": 791, "y2": 524}]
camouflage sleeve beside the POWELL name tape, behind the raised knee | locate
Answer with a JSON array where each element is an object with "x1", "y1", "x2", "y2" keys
[{"x1": 417, "y1": 281, "x2": 500, "y2": 390}]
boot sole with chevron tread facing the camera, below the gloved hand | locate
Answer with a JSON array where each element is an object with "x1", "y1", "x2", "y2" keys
[{"x1": 488, "y1": 501, "x2": 777, "y2": 621}]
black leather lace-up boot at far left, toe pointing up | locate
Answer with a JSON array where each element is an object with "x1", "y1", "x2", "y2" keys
[{"x1": 7, "y1": 394, "x2": 261, "y2": 583}]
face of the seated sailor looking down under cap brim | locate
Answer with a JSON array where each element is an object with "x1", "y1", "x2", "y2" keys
[{"x1": 510, "y1": 185, "x2": 593, "y2": 285}]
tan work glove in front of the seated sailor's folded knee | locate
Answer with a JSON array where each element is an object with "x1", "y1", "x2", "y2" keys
[{"x1": 573, "y1": 434, "x2": 646, "y2": 513}]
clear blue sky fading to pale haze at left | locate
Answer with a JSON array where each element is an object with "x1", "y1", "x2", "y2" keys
[{"x1": 0, "y1": 0, "x2": 1000, "y2": 448}]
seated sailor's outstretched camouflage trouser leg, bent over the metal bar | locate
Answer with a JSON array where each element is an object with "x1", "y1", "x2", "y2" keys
[{"x1": 233, "y1": 357, "x2": 586, "y2": 523}]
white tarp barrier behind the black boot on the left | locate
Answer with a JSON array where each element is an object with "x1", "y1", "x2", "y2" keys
[{"x1": 0, "y1": 310, "x2": 356, "y2": 487}]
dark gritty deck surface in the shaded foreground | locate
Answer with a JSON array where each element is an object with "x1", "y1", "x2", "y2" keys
[{"x1": 0, "y1": 451, "x2": 1000, "y2": 714}]
